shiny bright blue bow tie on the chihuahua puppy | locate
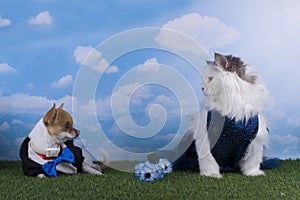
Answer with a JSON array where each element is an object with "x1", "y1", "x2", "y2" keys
[{"x1": 42, "y1": 147, "x2": 75, "y2": 177}]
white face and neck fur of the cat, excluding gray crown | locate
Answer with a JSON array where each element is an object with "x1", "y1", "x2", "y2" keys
[{"x1": 202, "y1": 65, "x2": 269, "y2": 120}]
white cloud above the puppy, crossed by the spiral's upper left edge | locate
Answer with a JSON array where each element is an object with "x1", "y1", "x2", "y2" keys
[{"x1": 73, "y1": 46, "x2": 119, "y2": 74}]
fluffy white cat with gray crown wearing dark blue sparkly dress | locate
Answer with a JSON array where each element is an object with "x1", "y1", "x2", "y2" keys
[{"x1": 192, "y1": 53, "x2": 269, "y2": 178}]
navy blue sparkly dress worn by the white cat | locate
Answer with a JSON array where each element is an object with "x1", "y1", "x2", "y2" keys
[{"x1": 173, "y1": 111, "x2": 259, "y2": 171}]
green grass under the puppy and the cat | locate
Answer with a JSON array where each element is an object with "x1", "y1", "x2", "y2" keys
[{"x1": 0, "y1": 159, "x2": 300, "y2": 200}]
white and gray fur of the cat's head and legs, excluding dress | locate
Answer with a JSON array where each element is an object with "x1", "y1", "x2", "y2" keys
[{"x1": 191, "y1": 53, "x2": 269, "y2": 178}]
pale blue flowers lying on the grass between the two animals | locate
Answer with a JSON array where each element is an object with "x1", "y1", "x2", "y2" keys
[{"x1": 134, "y1": 158, "x2": 173, "y2": 183}]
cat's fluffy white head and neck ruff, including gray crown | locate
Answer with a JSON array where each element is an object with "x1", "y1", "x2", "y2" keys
[{"x1": 202, "y1": 53, "x2": 269, "y2": 121}]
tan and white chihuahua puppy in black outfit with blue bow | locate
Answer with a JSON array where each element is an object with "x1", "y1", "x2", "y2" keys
[{"x1": 20, "y1": 103, "x2": 109, "y2": 178}]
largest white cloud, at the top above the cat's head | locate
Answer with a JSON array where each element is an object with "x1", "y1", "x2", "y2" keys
[{"x1": 156, "y1": 13, "x2": 239, "y2": 50}]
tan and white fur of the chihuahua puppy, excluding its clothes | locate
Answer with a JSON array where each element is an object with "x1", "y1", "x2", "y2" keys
[{"x1": 29, "y1": 103, "x2": 109, "y2": 177}]
